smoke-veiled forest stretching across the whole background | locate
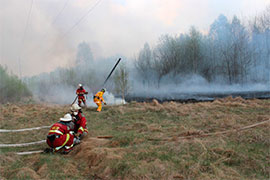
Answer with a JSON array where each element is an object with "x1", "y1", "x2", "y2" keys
[{"x1": 1, "y1": 7, "x2": 270, "y2": 103}]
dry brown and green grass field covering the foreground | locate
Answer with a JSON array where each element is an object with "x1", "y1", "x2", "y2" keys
[{"x1": 0, "y1": 97, "x2": 270, "y2": 180}]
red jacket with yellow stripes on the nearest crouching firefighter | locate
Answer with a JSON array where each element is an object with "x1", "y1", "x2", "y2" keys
[{"x1": 47, "y1": 121, "x2": 74, "y2": 152}]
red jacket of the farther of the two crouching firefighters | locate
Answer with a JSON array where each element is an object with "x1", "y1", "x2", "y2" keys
[{"x1": 72, "y1": 111, "x2": 88, "y2": 134}]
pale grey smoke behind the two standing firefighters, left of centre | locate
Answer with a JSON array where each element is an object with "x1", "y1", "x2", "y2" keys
[{"x1": 24, "y1": 48, "x2": 125, "y2": 107}]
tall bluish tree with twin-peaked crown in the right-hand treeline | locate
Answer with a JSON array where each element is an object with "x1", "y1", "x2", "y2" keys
[{"x1": 209, "y1": 15, "x2": 253, "y2": 84}]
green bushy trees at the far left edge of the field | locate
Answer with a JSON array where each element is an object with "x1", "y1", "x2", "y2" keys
[{"x1": 0, "y1": 65, "x2": 32, "y2": 103}]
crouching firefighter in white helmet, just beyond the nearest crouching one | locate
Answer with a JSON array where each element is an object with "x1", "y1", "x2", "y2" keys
[{"x1": 70, "y1": 104, "x2": 88, "y2": 140}]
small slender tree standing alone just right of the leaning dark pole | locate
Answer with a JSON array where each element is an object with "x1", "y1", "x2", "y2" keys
[{"x1": 114, "y1": 64, "x2": 131, "y2": 100}]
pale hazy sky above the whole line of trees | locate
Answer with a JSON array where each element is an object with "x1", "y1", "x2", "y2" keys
[{"x1": 0, "y1": 0, "x2": 270, "y2": 77}]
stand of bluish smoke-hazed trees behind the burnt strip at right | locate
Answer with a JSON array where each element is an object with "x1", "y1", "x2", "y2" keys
[{"x1": 135, "y1": 6, "x2": 270, "y2": 86}]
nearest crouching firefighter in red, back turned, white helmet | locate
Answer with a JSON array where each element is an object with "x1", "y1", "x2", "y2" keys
[{"x1": 47, "y1": 114, "x2": 80, "y2": 154}]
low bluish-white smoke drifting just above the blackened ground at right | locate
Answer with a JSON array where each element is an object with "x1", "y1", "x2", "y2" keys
[{"x1": 131, "y1": 75, "x2": 270, "y2": 98}]
